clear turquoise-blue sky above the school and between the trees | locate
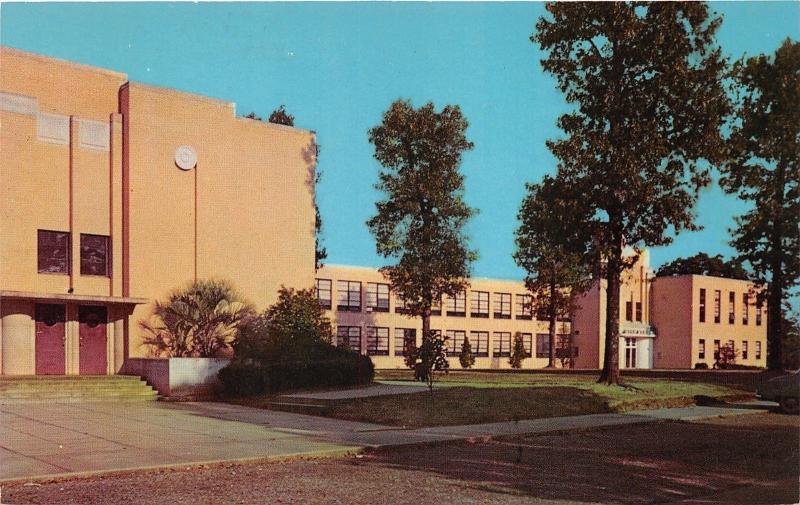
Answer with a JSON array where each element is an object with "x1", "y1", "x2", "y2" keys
[{"x1": 0, "y1": 2, "x2": 800, "y2": 279}]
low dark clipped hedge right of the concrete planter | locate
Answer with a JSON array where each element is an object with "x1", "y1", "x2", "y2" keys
[{"x1": 219, "y1": 353, "x2": 375, "y2": 396}]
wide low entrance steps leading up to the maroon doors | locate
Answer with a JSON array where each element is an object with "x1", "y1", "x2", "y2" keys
[{"x1": 0, "y1": 375, "x2": 158, "y2": 404}]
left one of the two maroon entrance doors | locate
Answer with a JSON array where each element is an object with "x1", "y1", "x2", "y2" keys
[{"x1": 36, "y1": 304, "x2": 67, "y2": 375}]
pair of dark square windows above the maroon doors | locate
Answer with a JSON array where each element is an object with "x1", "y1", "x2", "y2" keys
[{"x1": 37, "y1": 230, "x2": 111, "y2": 277}]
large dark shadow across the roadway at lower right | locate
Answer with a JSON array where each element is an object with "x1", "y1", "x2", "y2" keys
[{"x1": 365, "y1": 414, "x2": 800, "y2": 505}]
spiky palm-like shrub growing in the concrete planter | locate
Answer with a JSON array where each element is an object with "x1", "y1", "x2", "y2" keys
[{"x1": 139, "y1": 280, "x2": 255, "y2": 357}]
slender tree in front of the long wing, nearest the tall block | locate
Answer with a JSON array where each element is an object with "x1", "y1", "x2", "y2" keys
[{"x1": 367, "y1": 100, "x2": 476, "y2": 376}]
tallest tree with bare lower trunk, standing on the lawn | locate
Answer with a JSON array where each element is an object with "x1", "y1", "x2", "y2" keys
[{"x1": 531, "y1": 2, "x2": 730, "y2": 384}]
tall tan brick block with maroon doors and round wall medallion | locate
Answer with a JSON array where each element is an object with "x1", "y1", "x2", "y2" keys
[{"x1": 0, "y1": 48, "x2": 316, "y2": 375}]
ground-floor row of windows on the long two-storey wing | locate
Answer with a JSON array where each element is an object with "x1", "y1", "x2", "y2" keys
[{"x1": 336, "y1": 326, "x2": 578, "y2": 358}]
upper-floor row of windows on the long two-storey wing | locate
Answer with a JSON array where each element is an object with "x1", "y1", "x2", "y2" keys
[{"x1": 317, "y1": 279, "x2": 560, "y2": 320}]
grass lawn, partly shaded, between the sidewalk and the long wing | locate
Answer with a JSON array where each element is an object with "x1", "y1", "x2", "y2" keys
[{"x1": 237, "y1": 371, "x2": 747, "y2": 427}]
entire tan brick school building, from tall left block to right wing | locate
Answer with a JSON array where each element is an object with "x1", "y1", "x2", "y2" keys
[{"x1": 0, "y1": 48, "x2": 766, "y2": 375}]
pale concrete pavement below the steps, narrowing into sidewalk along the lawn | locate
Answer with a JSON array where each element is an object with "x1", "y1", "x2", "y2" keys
[{"x1": 0, "y1": 402, "x2": 766, "y2": 482}]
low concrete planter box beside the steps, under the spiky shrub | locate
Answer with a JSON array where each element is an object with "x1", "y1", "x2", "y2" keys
[{"x1": 122, "y1": 358, "x2": 231, "y2": 396}]
